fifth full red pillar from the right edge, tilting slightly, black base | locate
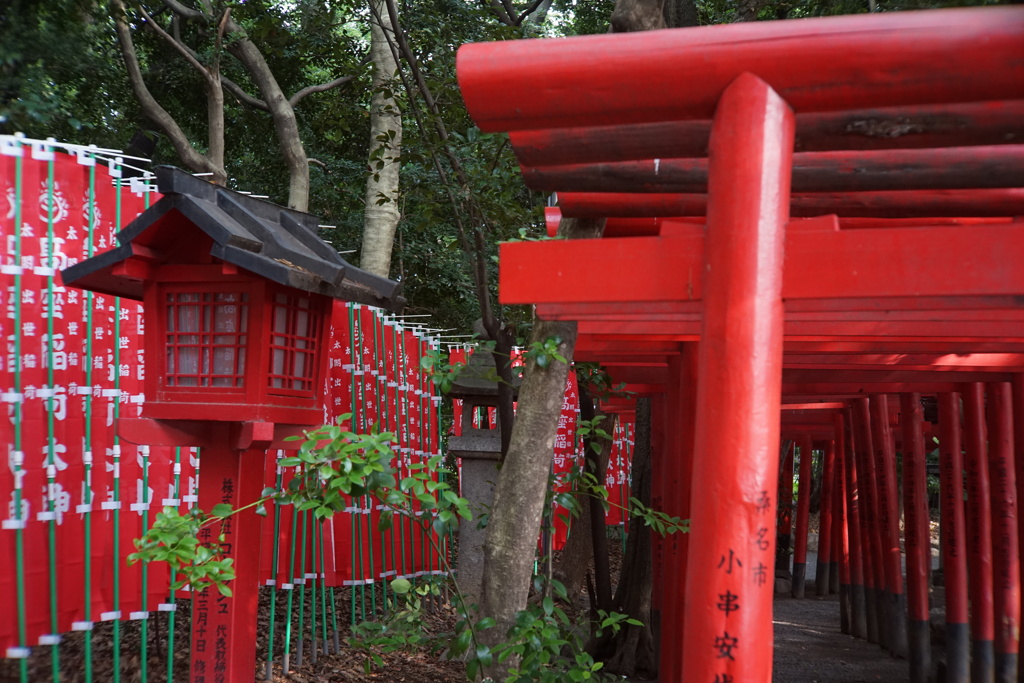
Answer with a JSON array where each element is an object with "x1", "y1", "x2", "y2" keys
[{"x1": 870, "y1": 394, "x2": 907, "y2": 657}]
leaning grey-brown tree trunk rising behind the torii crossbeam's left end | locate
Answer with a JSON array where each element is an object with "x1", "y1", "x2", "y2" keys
[{"x1": 480, "y1": 218, "x2": 604, "y2": 680}]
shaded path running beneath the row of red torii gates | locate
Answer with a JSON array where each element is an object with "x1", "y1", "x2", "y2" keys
[{"x1": 772, "y1": 595, "x2": 907, "y2": 683}]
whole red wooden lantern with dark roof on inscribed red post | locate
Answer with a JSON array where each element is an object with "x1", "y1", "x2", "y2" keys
[{"x1": 61, "y1": 167, "x2": 403, "y2": 683}]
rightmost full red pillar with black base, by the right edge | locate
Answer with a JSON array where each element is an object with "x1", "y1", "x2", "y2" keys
[{"x1": 985, "y1": 382, "x2": 1021, "y2": 681}]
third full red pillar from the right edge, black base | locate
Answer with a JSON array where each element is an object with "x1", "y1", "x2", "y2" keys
[{"x1": 938, "y1": 393, "x2": 971, "y2": 683}]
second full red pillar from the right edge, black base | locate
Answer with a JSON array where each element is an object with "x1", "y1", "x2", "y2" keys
[{"x1": 963, "y1": 382, "x2": 994, "y2": 681}]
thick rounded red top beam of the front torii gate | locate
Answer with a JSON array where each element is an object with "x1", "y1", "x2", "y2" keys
[{"x1": 457, "y1": 7, "x2": 1024, "y2": 131}]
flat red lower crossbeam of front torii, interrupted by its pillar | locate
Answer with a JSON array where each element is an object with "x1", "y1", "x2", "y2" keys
[{"x1": 500, "y1": 219, "x2": 1024, "y2": 305}]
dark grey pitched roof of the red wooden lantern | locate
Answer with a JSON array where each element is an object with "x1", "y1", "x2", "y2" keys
[{"x1": 61, "y1": 166, "x2": 406, "y2": 310}]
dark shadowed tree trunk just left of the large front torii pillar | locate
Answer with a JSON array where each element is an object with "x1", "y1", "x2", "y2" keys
[{"x1": 594, "y1": 398, "x2": 657, "y2": 678}]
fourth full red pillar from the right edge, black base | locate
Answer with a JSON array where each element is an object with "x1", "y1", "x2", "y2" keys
[{"x1": 900, "y1": 393, "x2": 932, "y2": 683}]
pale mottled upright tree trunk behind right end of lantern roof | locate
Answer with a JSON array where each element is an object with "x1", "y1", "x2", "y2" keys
[{"x1": 359, "y1": 0, "x2": 401, "y2": 278}]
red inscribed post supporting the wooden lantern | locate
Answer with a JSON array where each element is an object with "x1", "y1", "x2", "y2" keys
[{"x1": 190, "y1": 447, "x2": 266, "y2": 683}]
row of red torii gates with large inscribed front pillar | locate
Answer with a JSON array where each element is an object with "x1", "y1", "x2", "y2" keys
[{"x1": 459, "y1": 8, "x2": 1024, "y2": 683}]
